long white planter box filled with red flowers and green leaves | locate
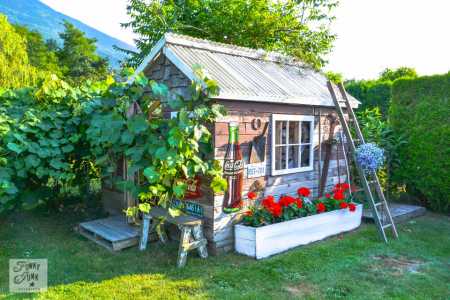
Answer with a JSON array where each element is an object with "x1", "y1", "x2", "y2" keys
[{"x1": 235, "y1": 184, "x2": 362, "y2": 259}]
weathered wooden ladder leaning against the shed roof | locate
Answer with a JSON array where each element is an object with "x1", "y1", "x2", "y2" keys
[{"x1": 327, "y1": 81, "x2": 398, "y2": 243}]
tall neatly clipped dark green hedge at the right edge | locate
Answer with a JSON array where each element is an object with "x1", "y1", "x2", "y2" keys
[{"x1": 389, "y1": 72, "x2": 450, "y2": 212}]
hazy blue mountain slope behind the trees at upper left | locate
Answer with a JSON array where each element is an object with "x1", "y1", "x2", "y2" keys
[{"x1": 0, "y1": 0, "x2": 135, "y2": 67}]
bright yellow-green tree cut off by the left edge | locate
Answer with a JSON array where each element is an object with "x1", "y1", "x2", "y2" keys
[{"x1": 0, "y1": 14, "x2": 38, "y2": 88}]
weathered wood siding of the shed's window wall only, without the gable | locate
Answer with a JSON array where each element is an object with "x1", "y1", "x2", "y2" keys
[{"x1": 213, "y1": 100, "x2": 346, "y2": 252}]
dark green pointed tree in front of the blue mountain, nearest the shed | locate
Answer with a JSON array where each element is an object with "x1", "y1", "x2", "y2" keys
[{"x1": 57, "y1": 21, "x2": 108, "y2": 83}]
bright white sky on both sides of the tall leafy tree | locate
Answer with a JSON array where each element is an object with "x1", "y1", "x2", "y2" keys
[{"x1": 41, "y1": 0, "x2": 450, "y2": 79}]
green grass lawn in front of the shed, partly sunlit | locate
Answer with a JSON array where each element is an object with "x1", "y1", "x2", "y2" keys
[{"x1": 0, "y1": 206, "x2": 450, "y2": 299}]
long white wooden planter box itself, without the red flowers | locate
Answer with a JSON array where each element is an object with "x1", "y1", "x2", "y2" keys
[{"x1": 234, "y1": 204, "x2": 363, "y2": 259}]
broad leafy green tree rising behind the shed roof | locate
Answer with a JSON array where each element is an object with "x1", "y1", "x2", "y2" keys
[{"x1": 123, "y1": 0, "x2": 337, "y2": 68}]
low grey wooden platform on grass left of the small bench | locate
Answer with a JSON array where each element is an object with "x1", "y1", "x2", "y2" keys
[{"x1": 77, "y1": 216, "x2": 139, "y2": 251}]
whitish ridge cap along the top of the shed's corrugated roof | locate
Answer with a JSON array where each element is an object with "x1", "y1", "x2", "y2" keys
[{"x1": 164, "y1": 32, "x2": 306, "y2": 67}]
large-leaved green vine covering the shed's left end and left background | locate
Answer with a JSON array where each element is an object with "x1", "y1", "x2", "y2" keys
[{"x1": 0, "y1": 71, "x2": 225, "y2": 212}]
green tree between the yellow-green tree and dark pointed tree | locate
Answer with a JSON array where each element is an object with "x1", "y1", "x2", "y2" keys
[{"x1": 14, "y1": 25, "x2": 61, "y2": 76}]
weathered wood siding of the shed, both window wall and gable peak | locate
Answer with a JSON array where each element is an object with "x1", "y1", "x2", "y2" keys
[{"x1": 144, "y1": 55, "x2": 345, "y2": 254}]
